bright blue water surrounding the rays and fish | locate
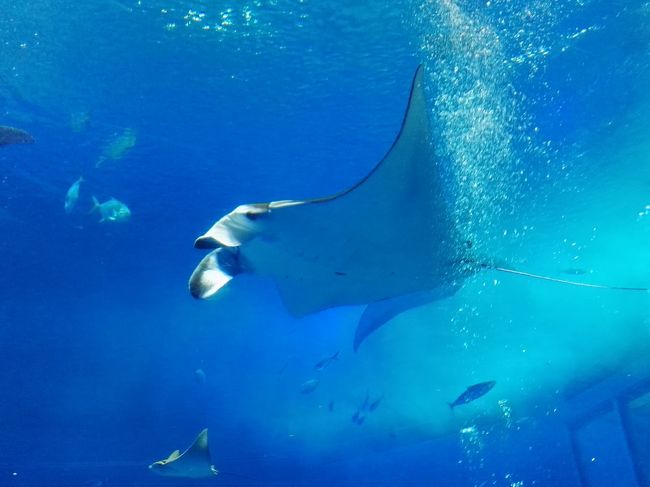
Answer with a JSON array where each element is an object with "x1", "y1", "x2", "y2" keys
[{"x1": 0, "y1": 0, "x2": 650, "y2": 487}]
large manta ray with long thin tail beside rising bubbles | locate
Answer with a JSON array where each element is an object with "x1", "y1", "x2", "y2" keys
[{"x1": 189, "y1": 66, "x2": 644, "y2": 350}]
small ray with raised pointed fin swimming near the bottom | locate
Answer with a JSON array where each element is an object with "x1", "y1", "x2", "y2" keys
[{"x1": 149, "y1": 428, "x2": 219, "y2": 479}]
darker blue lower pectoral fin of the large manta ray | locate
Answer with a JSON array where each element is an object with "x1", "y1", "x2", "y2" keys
[{"x1": 353, "y1": 285, "x2": 458, "y2": 352}]
